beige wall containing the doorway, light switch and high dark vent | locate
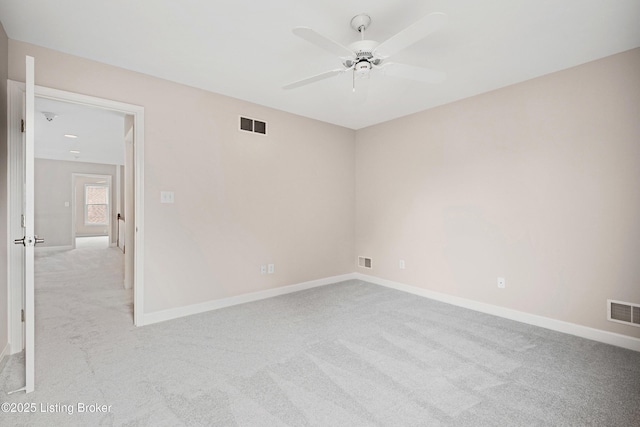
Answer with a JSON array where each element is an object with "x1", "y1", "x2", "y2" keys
[{"x1": 9, "y1": 40, "x2": 355, "y2": 313}]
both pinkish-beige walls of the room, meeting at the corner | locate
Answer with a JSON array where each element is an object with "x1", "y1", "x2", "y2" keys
[{"x1": 9, "y1": 41, "x2": 640, "y2": 337}]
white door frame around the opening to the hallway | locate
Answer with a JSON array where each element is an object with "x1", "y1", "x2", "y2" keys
[{"x1": 7, "y1": 80, "x2": 144, "y2": 354}]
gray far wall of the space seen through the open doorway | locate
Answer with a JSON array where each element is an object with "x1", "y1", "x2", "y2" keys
[{"x1": 34, "y1": 159, "x2": 117, "y2": 247}]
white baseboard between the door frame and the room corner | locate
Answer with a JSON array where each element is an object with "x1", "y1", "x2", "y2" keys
[{"x1": 144, "y1": 273, "x2": 356, "y2": 325}]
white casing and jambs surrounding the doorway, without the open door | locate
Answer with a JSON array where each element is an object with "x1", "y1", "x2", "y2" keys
[{"x1": 8, "y1": 81, "x2": 144, "y2": 362}]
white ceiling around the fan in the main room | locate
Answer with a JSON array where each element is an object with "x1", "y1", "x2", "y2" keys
[{"x1": 0, "y1": 0, "x2": 640, "y2": 129}]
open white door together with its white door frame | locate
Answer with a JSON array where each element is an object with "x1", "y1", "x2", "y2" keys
[{"x1": 8, "y1": 61, "x2": 144, "y2": 393}]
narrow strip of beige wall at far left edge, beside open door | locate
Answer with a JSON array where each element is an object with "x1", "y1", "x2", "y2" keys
[{"x1": 0, "y1": 22, "x2": 10, "y2": 358}]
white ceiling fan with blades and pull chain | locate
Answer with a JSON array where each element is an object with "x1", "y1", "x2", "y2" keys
[{"x1": 283, "y1": 12, "x2": 447, "y2": 91}]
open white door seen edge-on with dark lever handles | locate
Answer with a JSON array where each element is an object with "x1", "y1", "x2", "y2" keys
[{"x1": 14, "y1": 56, "x2": 37, "y2": 393}]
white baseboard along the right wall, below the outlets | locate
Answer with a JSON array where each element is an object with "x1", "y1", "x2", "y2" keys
[{"x1": 355, "y1": 273, "x2": 640, "y2": 352}]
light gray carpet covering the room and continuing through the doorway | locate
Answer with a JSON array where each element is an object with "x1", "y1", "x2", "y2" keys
[{"x1": 0, "y1": 249, "x2": 640, "y2": 426}]
